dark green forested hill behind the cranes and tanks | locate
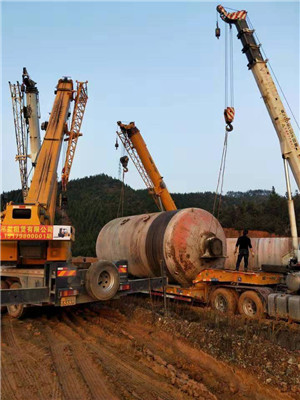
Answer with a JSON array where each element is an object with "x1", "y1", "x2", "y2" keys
[{"x1": 1, "y1": 174, "x2": 300, "y2": 256}]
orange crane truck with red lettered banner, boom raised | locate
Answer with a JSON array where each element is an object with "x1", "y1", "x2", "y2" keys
[{"x1": 0, "y1": 77, "x2": 165, "y2": 318}]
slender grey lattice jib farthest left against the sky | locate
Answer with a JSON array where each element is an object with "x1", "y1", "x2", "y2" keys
[{"x1": 9, "y1": 82, "x2": 28, "y2": 200}]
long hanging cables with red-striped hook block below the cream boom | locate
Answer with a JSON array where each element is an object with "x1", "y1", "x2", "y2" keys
[{"x1": 212, "y1": 21, "x2": 234, "y2": 219}]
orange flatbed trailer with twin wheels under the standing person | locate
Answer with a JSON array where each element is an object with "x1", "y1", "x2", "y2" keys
[{"x1": 152, "y1": 269, "x2": 300, "y2": 322}]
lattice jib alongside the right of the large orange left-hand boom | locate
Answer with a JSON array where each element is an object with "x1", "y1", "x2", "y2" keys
[{"x1": 61, "y1": 82, "x2": 88, "y2": 192}]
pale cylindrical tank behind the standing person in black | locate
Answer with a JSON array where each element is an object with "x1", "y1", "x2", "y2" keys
[{"x1": 225, "y1": 237, "x2": 292, "y2": 270}]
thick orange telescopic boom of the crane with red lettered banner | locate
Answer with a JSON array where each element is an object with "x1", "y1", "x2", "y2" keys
[{"x1": 25, "y1": 78, "x2": 73, "y2": 224}]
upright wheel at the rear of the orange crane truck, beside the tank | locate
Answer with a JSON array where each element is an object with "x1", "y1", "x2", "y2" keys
[{"x1": 85, "y1": 261, "x2": 120, "y2": 300}]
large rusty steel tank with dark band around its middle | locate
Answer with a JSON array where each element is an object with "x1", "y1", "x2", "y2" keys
[{"x1": 96, "y1": 208, "x2": 226, "y2": 286}]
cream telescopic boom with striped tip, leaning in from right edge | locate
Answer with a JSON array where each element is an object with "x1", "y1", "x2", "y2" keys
[{"x1": 217, "y1": 5, "x2": 300, "y2": 189}]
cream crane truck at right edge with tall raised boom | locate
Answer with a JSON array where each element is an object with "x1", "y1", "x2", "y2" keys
[{"x1": 213, "y1": 5, "x2": 300, "y2": 321}]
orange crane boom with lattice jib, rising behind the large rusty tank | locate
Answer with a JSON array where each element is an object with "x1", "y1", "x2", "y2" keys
[{"x1": 117, "y1": 121, "x2": 177, "y2": 211}]
